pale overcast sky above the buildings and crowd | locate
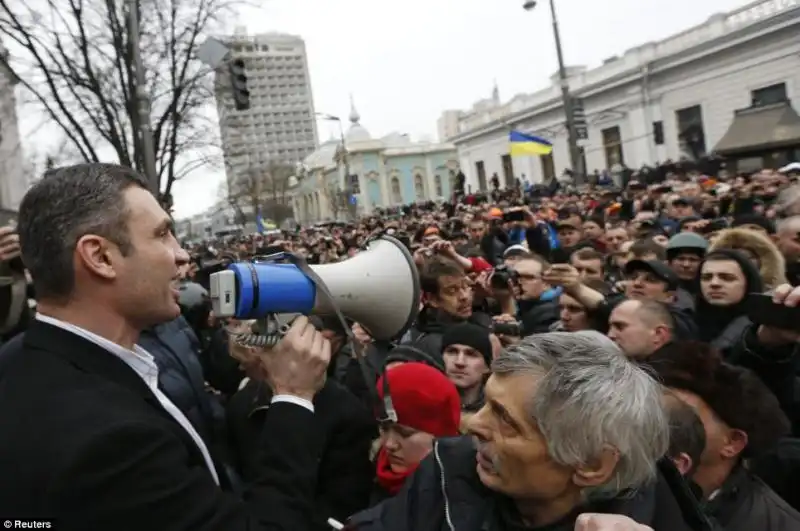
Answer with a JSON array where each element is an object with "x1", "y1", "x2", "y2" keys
[{"x1": 28, "y1": 0, "x2": 747, "y2": 217}]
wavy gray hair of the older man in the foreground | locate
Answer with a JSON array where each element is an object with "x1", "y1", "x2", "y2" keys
[{"x1": 492, "y1": 331, "x2": 669, "y2": 499}]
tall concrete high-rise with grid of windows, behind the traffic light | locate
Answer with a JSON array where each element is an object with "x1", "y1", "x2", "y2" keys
[{"x1": 215, "y1": 28, "x2": 317, "y2": 185}]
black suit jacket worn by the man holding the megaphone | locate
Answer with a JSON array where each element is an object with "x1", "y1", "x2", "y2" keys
[{"x1": 0, "y1": 321, "x2": 324, "y2": 531}]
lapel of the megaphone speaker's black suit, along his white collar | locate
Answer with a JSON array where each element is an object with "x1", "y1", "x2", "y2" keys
[{"x1": 23, "y1": 320, "x2": 211, "y2": 464}]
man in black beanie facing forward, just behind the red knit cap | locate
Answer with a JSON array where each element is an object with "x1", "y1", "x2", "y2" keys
[{"x1": 442, "y1": 323, "x2": 492, "y2": 413}]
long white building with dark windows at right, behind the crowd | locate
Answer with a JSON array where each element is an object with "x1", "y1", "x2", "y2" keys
[{"x1": 446, "y1": 0, "x2": 800, "y2": 191}]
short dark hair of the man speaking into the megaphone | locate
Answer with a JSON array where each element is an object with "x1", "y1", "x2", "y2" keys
[{"x1": 17, "y1": 163, "x2": 147, "y2": 301}]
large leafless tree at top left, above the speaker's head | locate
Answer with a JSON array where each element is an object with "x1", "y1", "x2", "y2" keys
[{"x1": 0, "y1": 0, "x2": 250, "y2": 197}]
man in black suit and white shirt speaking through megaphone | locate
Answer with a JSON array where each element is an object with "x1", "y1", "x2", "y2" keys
[{"x1": 0, "y1": 164, "x2": 330, "y2": 531}]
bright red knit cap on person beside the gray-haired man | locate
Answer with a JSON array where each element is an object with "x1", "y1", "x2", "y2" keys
[{"x1": 378, "y1": 363, "x2": 461, "y2": 437}]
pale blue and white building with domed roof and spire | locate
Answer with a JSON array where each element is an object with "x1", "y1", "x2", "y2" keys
[{"x1": 291, "y1": 101, "x2": 459, "y2": 224}]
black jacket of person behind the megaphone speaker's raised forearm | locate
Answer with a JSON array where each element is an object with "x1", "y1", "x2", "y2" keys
[{"x1": 228, "y1": 380, "x2": 378, "y2": 531}]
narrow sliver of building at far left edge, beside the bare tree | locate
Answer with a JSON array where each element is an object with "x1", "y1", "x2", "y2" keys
[{"x1": 0, "y1": 43, "x2": 29, "y2": 212}]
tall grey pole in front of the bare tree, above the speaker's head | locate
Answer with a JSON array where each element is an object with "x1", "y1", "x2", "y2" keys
[{"x1": 128, "y1": 0, "x2": 160, "y2": 198}]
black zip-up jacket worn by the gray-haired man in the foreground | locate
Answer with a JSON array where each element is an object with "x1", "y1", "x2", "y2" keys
[{"x1": 347, "y1": 437, "x2": 707, "y2": 531}]
